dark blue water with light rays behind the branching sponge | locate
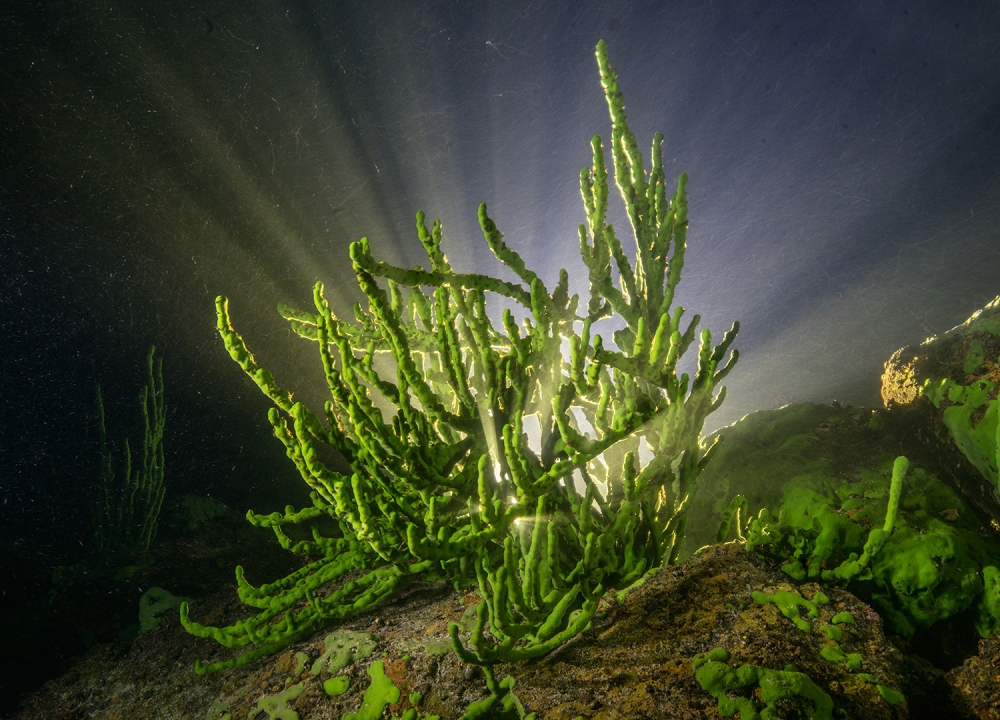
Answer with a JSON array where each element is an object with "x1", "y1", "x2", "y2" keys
[{"x1": 0, "y1": 0, "x2": 1000, "y2": 715}]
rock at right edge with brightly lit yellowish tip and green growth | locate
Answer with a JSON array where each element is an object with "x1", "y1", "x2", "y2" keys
[{"x1": 882, "y1": 296, "x2": 1000, "y2": 526}]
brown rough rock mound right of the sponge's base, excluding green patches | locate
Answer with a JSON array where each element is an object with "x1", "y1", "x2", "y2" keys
[{"x1": 484, "y1": 544, "x2": 929, "y2": 720}]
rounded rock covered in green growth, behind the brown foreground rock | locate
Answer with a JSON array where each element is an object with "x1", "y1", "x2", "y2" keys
[{"x1": 682, "y1": 403, "x2": 1000, "y2": 637}]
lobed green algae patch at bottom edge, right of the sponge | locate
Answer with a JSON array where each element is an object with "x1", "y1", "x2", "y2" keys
[{"x1": 693, "y1": 648, "x2": 833, "y2": 720}]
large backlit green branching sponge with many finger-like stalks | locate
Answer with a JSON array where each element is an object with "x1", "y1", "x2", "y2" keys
[{"x1": 181, "y1": 36, "x2": 738, "y2": 704}]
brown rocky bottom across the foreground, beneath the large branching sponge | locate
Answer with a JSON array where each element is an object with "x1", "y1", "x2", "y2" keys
[{"x1": 12, "y1": 543, "x2": 954, "y2": 720}]
